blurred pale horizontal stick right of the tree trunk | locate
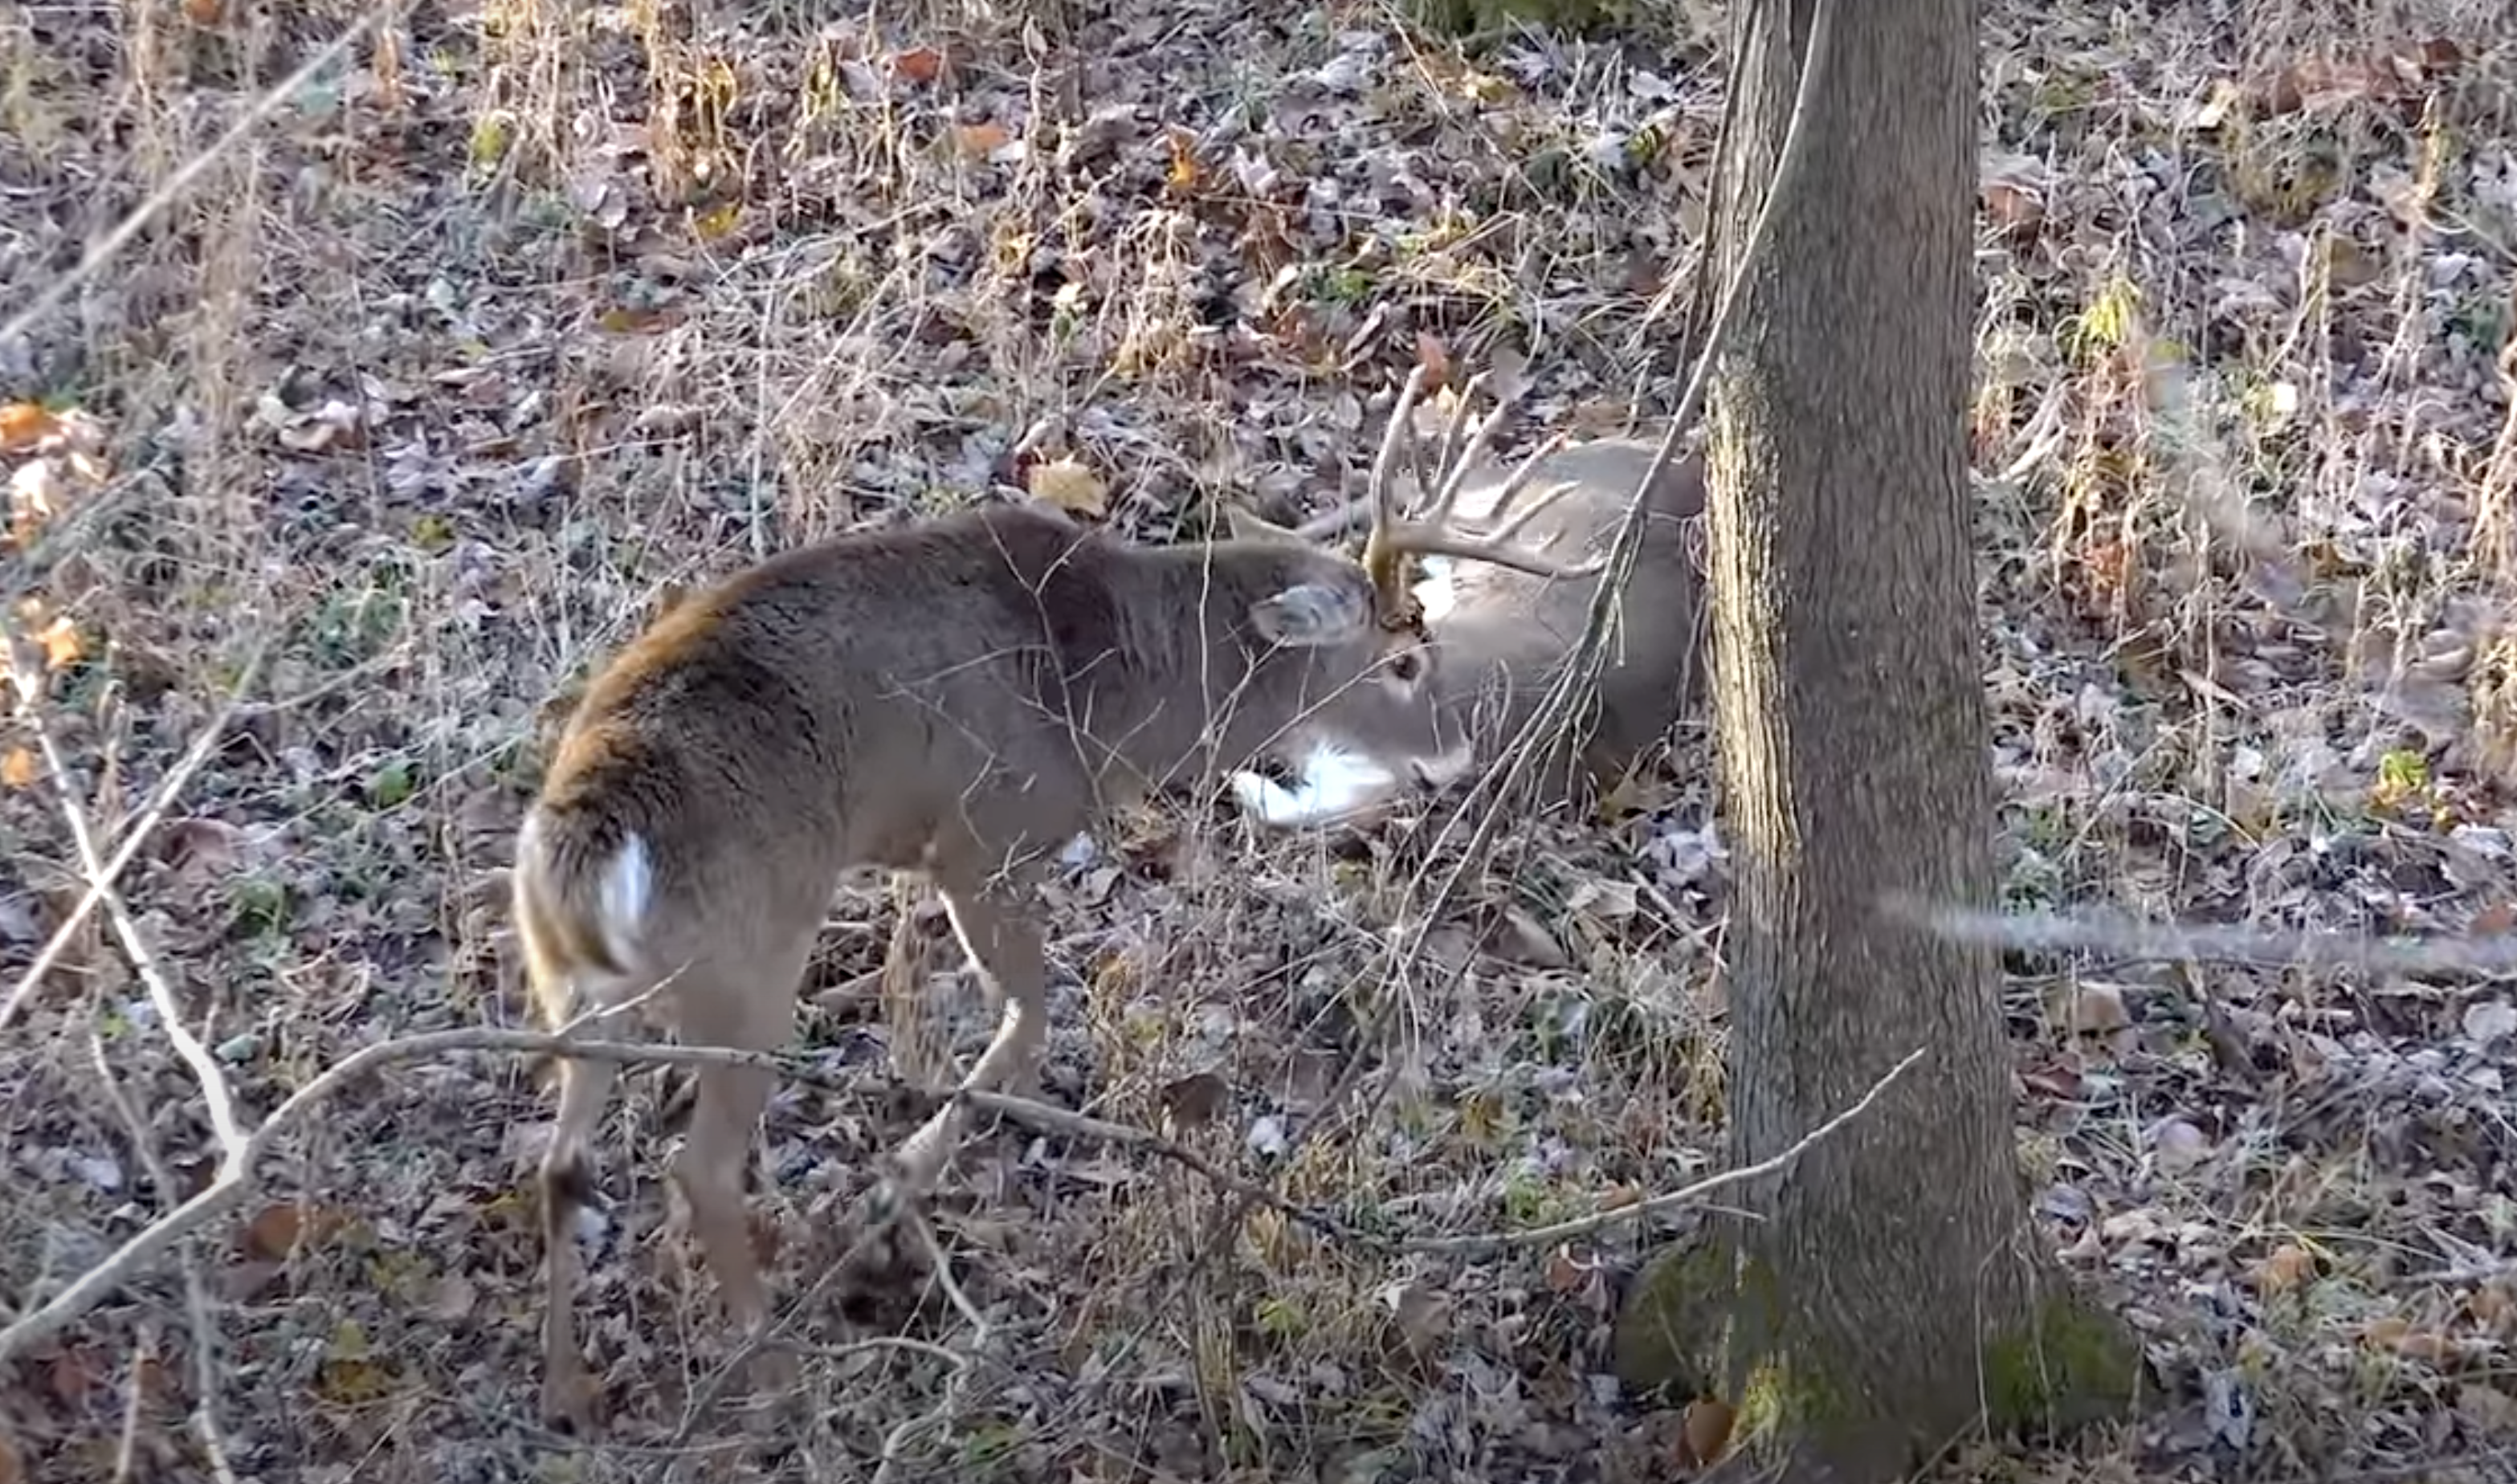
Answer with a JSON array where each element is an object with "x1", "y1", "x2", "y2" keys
[{"x1": 1880, "y1": 895, "x2": 2517, "y2": 973}]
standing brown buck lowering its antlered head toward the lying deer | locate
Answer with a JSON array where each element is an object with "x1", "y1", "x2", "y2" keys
[{"x1": 513, "y1": 412, "x2": 1568, "y2": 1421}]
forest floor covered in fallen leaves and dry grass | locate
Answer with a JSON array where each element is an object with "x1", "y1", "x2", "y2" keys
[{"x1": 0, "y1": 0, "x2": 2517, "y2": 1484}]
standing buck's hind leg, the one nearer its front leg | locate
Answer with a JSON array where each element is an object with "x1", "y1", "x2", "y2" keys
[{"x1": 672, "y1": 938, "x2": 813, "y2": 1384}]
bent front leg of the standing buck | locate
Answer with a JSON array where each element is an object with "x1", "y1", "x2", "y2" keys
[{"x1": 894, "y1": 862, "x2": 1050, "y2": 1192}]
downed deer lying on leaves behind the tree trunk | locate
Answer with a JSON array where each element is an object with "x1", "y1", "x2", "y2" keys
[{"x1": 1234, "y1": 377, "x2": 1704, "y2": 825}]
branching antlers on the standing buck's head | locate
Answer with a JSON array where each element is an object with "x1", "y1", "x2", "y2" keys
[{"x1": 1359, "y1": 365, "x2": 1605, "y2": 614}]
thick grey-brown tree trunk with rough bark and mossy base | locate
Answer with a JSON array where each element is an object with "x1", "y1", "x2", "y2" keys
[{"x1": 1621, "y1": 0, "x2": 2135, "y2": 1479}]
